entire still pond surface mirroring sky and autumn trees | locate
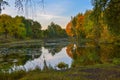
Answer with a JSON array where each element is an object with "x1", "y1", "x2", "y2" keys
[{"x1": 0, "y1": 44, "x2": 120, "y2": 72}]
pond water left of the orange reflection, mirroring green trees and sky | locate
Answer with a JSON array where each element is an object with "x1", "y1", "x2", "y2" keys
[{"x1": 0, "y1": 45, "x2": 72, "y2": 72}]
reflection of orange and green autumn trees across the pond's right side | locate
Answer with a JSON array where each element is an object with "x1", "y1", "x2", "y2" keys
[{"x1": 66, "y1": 44, "x2": 120, "y2": 67}]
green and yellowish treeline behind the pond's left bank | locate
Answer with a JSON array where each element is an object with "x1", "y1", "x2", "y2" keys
[{"x1": 0, "y1": 14, "x2": 67, "y2": 39}]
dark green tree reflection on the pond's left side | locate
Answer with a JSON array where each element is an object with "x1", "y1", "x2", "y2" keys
[{"x1": 0, "y1": 47, "x2": 42, "y2": 69}]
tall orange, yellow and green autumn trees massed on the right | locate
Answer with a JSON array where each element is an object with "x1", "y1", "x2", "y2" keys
[{"x1": 66, "y1": 0, "x2": 120, "y2": 45}]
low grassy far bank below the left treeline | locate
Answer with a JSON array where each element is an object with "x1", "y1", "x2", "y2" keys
[{"x1": 0, "y1": 38, "x2": 69, "y2": 47}]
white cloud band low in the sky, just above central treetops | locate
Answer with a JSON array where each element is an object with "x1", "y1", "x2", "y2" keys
[{"x1": 35, "y1": 14, "x2": 70, "y2": 29}]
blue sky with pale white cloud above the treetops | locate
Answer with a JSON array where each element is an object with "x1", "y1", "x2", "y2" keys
[{"x1": 2, "y1": 0, "x2": 92, "y2": 29}]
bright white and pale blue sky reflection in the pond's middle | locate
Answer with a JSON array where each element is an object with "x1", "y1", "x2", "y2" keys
[{"x1": 10, "y1": 47, "x2": 72, "y2": 71}]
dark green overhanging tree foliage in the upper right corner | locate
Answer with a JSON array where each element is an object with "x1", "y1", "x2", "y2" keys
[{"x1": 92, "y1": 0, "x2": 120, "y2": 38}]
